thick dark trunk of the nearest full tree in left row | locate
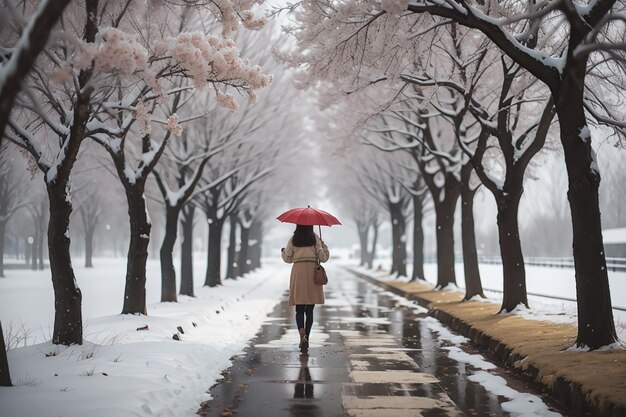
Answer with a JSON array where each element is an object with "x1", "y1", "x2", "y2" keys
[{"x1": 47, "y1": 184, "x2": 83, "y2": 346}]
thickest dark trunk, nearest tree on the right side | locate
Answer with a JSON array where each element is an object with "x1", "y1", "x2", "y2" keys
[{"x1": 556, "y1": 75, "x2": 617, "y2": 349}]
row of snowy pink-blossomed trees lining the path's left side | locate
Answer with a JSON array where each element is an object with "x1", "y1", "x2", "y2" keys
[{"x1": 0, "y1": 0, "x2": 299, "y2": 385}]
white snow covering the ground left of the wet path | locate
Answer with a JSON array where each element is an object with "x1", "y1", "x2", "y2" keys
[{"x1": 0, "y1": 260, "x2": 289, "y2": 417}]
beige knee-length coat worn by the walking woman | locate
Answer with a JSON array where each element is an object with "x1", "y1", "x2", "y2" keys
[{"x1": 281, "y1": 235, "x2": 330, "y2": 306}]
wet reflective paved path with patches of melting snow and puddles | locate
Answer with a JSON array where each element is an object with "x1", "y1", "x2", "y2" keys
[{"x1": 200, "y1": 268, "x2": 559, "y2": 417}]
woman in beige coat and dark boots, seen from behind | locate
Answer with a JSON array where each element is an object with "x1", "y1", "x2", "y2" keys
[{"x1": 281, "y1": 224, "x2": 330, "y2": 353}]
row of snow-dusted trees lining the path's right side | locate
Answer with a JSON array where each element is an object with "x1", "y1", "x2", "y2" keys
[{"x1": 284, "y1": 0, "x2": 626, "y2": 349}]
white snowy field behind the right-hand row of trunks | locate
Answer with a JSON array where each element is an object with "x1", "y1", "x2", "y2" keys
[{"x1": 348, "y1": 260, "x2": 626, "y2": 342}]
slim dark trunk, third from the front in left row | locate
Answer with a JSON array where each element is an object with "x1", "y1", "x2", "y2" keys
[{"x1": 159, "y1": 204, "x2": 179, "y2": 302}]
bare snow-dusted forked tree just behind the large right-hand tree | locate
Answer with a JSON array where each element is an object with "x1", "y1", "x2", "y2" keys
[{"x1": 407, "y1": 59, "x2": 555, "y2": 311}]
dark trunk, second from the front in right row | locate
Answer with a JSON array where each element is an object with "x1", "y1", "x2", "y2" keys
[{"x1": 496, "y1": 189, "x2": 528, "y2": 312}]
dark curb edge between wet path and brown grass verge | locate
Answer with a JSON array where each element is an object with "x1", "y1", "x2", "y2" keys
[{"x1": 345, "y1": 267, "x2": 626, "y2": 417}]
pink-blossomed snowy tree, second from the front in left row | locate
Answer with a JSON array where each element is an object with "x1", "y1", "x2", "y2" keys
[{"x1": 81, "y1": 4, "x2": 271, "y2": 314}]
